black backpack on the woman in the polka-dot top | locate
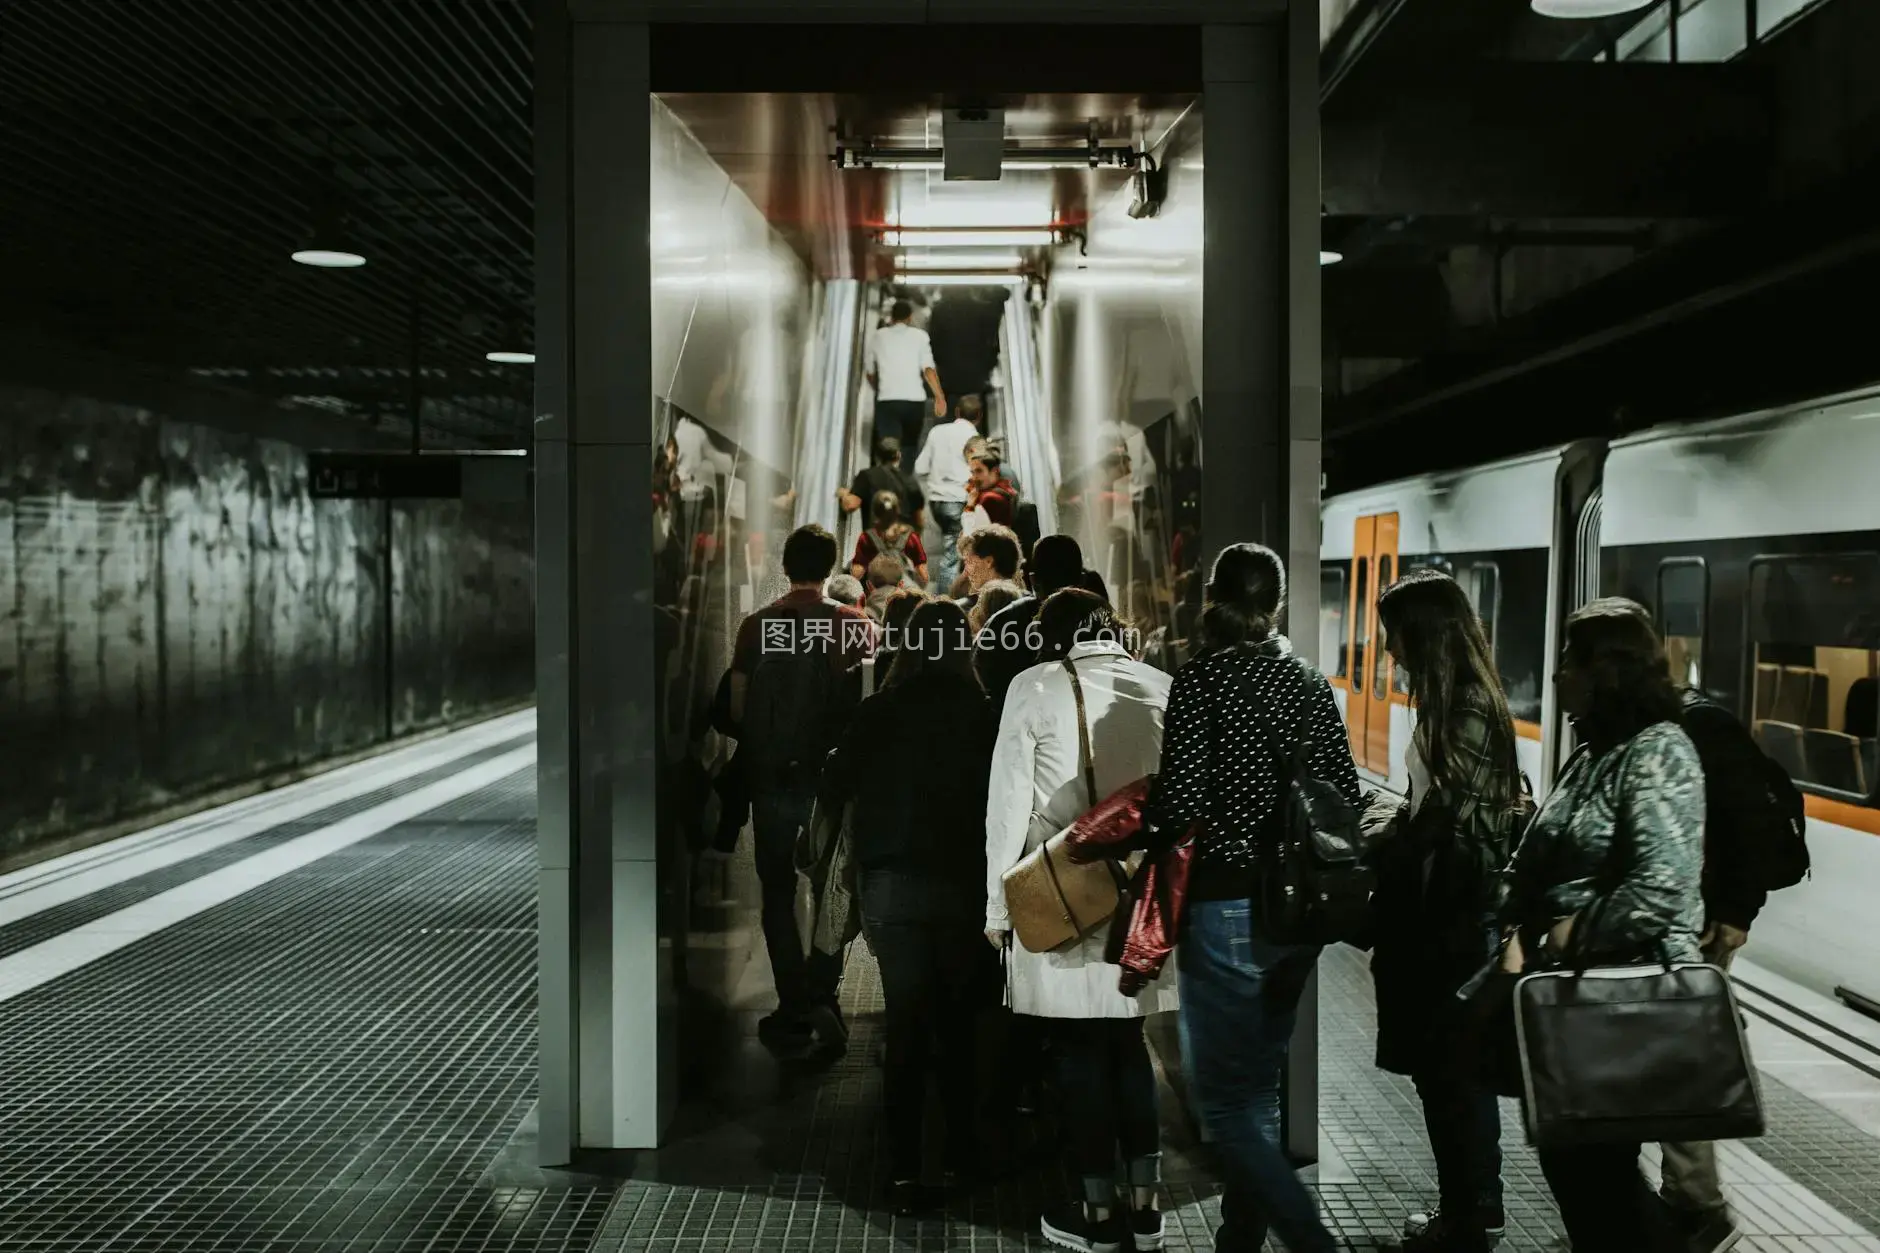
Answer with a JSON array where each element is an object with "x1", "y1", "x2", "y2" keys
[{"x1": 1241, "y1": 647, "x2": 1378, "y2": 944}]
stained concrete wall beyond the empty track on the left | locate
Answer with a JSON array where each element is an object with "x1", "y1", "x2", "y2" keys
[{"x1": 0, "y1": 386, "x2": 534, "y2": 862}]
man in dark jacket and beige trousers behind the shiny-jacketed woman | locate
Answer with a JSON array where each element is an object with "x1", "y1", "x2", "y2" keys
[{"x1": 1660, "y1": 690, "x2": 1777, "y2": 1253}]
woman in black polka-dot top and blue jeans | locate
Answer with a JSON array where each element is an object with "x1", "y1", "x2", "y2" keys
[{"x1": 1145, "y1": 544, "x2": 1361, "y2": 1253}]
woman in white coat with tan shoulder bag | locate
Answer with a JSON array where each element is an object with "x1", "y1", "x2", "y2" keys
[{"x1": 985, "y1": 589, "x2": 1177, "y2": 1253}]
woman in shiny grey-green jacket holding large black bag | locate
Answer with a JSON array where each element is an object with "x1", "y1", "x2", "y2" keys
[{"x1": 1500, "y1": 596, "x2": 1703, "y2": 1251}]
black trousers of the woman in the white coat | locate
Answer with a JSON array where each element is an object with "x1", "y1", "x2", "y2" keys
[{"x1": 1045, "y1": 1018, "x2": 1162, "y2": 1200}]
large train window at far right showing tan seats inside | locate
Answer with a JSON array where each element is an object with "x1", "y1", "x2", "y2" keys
[{"x1": 1748, "y1": 553, "x2": 1880, "y2": 798}]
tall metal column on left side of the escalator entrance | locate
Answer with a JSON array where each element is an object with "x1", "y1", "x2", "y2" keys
[{"x1": 534, "y1": 0, "x2": 677, "y2": 1165}]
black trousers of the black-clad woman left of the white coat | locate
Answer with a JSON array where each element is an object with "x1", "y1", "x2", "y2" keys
[{"x1": 863, "y1": 914, "x2": 991, "y2": 1180}]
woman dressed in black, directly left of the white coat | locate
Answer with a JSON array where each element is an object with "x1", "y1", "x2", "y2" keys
[{"x1": 823, "y1": 596, "x2": 996, "y2": 1213}]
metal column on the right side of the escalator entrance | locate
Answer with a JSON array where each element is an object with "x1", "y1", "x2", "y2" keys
[{"x1": 1201, "y1": 0, "x2": 1320, "y2": 1163}]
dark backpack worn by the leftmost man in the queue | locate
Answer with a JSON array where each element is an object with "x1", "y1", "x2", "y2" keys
[{"x1": 737, "y1": 600, "x2": 850, "y2": 792}]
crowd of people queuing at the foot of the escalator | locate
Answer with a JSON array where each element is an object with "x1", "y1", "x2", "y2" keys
[{"x1": 706, "y1": 507, "x2": 1762, "y2": 1253}]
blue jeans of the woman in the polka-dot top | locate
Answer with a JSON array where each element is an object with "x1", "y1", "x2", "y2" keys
[{"x1": 1175, "y1": 901, "x2": 1337, "y2": 1253}]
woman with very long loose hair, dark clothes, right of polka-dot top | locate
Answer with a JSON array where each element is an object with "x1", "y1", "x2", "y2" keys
[{"x1": 1371, "y1": 570, "x2": 1521, "y2": 1253}]
